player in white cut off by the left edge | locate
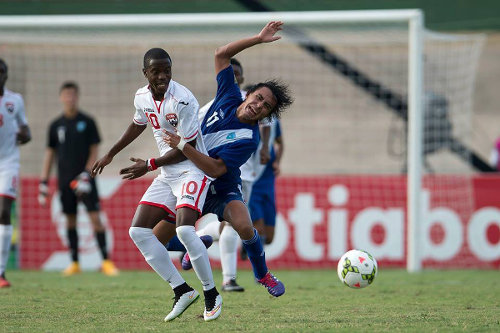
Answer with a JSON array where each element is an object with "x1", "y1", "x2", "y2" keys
[{"x1": 0, "y1": 59, "x2": 31, "y2": 288}]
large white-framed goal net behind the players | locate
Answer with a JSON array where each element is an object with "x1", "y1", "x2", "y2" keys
[{"x1": 0, "y1": 11, "x2": 492, "y2": 270}]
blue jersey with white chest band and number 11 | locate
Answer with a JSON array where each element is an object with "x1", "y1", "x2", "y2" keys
[{"x1": 201, "y1": 65, "x2": 260, "y2": 192}]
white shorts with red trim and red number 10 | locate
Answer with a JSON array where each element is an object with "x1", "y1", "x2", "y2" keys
[{"x1": 139, "y1": 173, "x2": 210, "y2": 223}]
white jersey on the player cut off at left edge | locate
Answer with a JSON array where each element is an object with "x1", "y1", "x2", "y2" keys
[{"x1": 0, "y1": 89, "x2": 28, "y2": 168}]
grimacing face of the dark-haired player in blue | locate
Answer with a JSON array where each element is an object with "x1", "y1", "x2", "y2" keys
[{"x1": 238, "y1": 87, "x2": 276, "y2": 122}]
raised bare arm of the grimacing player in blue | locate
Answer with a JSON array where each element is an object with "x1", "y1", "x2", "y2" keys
[{"x1": 215, "y1": 21, "x2": 283, "y2": 74}]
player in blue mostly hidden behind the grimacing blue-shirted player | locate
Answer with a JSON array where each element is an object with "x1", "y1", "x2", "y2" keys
[{"x1": 248, "y1": 119, "x2": 284, "y2": 244}]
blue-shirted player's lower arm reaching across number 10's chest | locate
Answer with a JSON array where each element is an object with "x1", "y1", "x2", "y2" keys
[{"x1": 163, "y1": 132, "x2": 227, "y2": 178}]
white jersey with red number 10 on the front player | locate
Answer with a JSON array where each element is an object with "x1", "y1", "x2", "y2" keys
[{"x1": 134, "y1": 80, "x2": 207, "y2": 178}]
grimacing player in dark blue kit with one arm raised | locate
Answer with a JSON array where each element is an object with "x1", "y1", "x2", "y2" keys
[{"x1": 165, "y1": 21, "x2": 292, "y2": 297}]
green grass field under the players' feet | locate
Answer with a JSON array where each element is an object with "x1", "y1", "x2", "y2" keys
[{"x1": 0, "y1": 269, "x2": 500, "y2": 332}]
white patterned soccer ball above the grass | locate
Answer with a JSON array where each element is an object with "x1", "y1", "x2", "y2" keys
[{"x1": 337, "y1": 250, "x2": 378, "y2": 288}]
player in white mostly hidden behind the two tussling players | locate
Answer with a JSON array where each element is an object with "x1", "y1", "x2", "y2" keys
[{"x1": 190, "y1": 58, "x2": 271, "y2": 292}]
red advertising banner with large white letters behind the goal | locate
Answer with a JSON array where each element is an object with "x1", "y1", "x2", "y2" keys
[{"x1": 20, "y1": 175, "x2": 500, "y2": 269}]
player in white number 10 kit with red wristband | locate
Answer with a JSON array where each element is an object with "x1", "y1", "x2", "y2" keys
[{"x1": 92, "y1": 48, "x2": 222, "y2": 321}]
